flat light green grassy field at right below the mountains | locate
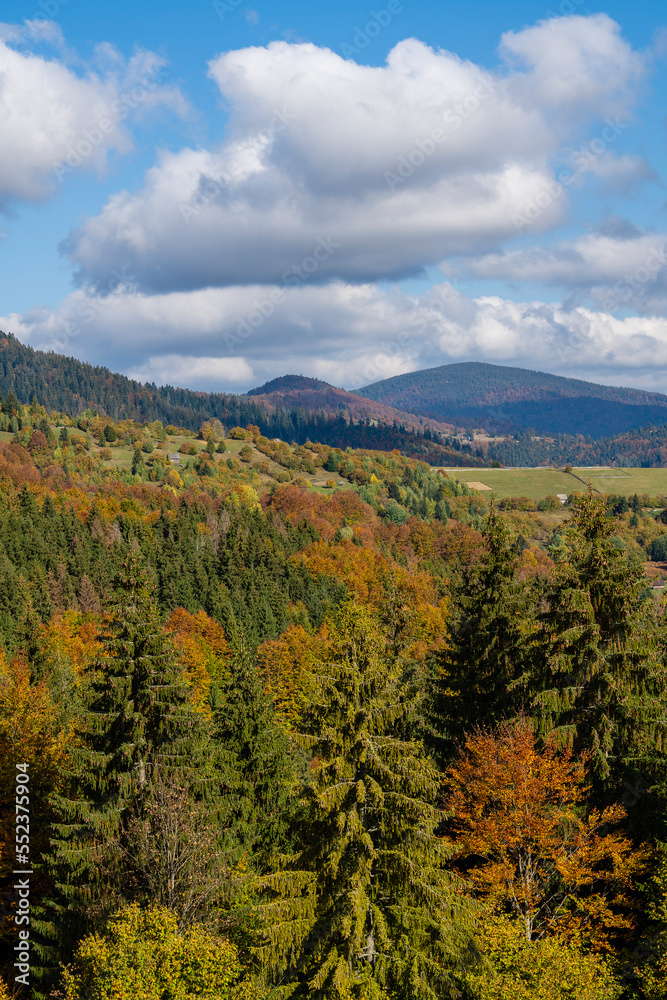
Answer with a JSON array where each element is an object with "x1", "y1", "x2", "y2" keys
[{"x1": 445, "y1": 468, "x2": 667, "y2": 500}]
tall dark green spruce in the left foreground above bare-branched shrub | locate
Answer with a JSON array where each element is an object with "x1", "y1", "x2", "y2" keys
[{"x1": 37, "y1": 550, "x2": 226, "y2": 978}]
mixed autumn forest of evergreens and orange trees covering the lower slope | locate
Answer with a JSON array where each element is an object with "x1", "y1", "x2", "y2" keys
[{"x1": 0, "y1": 388, "x2": 667, "y2": 1000}]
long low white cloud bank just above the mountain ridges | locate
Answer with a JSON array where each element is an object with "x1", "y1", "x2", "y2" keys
[{"x1": 0, "y1": 282, "x2": 667, "y2": 391}]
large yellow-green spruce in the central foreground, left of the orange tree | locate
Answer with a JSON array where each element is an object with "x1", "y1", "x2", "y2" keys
[{"x1": 260, "y1": 604, "x2": 469, "y2": 1000}]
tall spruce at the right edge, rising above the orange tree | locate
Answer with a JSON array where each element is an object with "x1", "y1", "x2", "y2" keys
[{"x1": 531, "y1": 489, "x2": 664, "y2": 782}]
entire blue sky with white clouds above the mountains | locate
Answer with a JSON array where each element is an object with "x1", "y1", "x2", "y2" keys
[{"x1": 0, "y1": 0, "x2": 667, "y2": 392}]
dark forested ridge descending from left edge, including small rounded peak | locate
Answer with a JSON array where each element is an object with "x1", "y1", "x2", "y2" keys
[{"x1": 0, "y1": 332, "x2": 484, "y2": 466}]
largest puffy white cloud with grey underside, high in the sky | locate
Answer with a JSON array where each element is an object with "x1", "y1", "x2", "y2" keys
[{"x1": 65, "y1": 14, "x2": 644, "y2": 293}]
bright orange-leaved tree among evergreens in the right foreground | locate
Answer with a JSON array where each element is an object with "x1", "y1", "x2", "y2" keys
[{"x1": 446, "y1": 719, "x2": 646, "y2": 949}]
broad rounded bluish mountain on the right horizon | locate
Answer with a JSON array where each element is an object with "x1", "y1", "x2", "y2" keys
[{"x1": 358, "y1": 361, "x2": 667, "y2": 438}]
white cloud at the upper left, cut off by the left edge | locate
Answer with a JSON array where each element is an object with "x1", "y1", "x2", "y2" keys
[{"x1": 0, "y1": 26, "x2": 187, "y2": 206}]
